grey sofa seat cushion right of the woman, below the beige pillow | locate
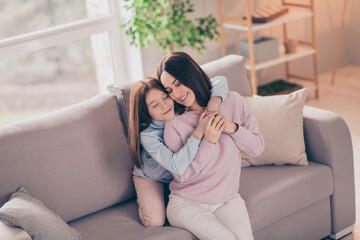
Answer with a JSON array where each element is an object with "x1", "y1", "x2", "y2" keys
[{"x1": 240, "y1": 162, "x2": 333, "y2": 232}]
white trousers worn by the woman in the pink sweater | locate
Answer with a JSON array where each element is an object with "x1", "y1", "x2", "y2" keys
[{"x1": 166, "y1": 194, "x2": 254, "y2": 240}]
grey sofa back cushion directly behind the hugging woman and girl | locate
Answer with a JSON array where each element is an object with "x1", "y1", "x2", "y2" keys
[{"x1": 108, "y1": 55, "x2": 252, "y2": 141}]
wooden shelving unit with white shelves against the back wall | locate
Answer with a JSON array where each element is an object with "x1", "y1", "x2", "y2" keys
[{"x1": 218, "y1": 0, "x2": 318, "y2": 97}]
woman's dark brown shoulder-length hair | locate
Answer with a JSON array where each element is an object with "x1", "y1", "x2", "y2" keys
[{"x1": 157, "y1": 52, "x2": 211, "y2": 114}]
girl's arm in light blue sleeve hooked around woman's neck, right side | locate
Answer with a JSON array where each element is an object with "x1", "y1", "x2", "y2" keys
[{"x1": 207, "y1": 76, "x2": 229, "y2": 112}]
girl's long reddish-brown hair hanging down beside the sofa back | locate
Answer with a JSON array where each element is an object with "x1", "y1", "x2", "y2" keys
[{"x1": 129, "y1": 77, "x2": 165, "y2": 168}]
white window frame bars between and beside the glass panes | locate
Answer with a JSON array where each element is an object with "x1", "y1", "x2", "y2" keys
[{"x1": 0, "y1": 0, "x2": 143, "y2": 84}]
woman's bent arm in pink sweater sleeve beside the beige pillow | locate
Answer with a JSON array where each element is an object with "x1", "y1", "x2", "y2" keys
[{"x1": 225, "y1": 94, "x2": 265, "y2": 157}]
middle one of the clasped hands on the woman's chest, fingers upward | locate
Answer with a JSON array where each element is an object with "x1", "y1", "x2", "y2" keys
[{"x1": 204, "y1": 114, "x2": 225, "y2": 144}]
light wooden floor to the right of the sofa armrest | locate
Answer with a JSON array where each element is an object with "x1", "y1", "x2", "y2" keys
[{"x1": 305, "y1": 65, "x2": 360, "y2": 240}]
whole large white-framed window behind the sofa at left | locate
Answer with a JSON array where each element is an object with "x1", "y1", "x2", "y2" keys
[{"x1": 0, "y1": 0, "x2": 142, "y2": 126}]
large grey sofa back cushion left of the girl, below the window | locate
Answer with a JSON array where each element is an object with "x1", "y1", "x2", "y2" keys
[{"x1": 0, "y1": 95, "x2": 135, "y2": 221}]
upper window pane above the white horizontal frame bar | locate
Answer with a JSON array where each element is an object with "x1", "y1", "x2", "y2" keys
[{"x1": 0, "y1": 0, "x2": 110, "y2": 39}]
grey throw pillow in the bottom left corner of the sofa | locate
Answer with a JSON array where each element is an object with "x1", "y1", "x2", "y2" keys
[{"x1": 0, "y1": 187, "x2": 81, "y2": 240}]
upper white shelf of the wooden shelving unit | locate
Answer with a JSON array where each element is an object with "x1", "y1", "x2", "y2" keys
[{"x1": 223, "y1": 10, "x2": 313, "y2": 31}]
